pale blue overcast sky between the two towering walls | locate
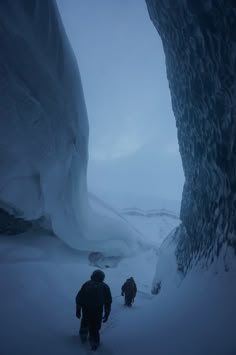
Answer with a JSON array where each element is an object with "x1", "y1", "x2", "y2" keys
[{"x1": 57, "y1": 0, "x2": 184, "y2": 206}]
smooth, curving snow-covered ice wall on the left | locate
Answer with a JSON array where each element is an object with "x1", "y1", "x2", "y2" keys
[{"x1": 0, "y1": 0, "x2": 136, "y2": 254}]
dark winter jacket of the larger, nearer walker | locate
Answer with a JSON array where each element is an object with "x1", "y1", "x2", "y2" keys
[{"x1": 76, "y1": 280, "x2": 112, "y2": 317}]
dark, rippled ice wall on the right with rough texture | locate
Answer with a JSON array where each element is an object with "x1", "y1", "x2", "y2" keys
[{"x1": 146, "y1": 0, "x2": 236, "y2": 271}]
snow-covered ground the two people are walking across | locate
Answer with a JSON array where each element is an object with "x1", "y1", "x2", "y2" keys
[{"x1": 0, "y1": 206, "x2": 236, "y2": 355}]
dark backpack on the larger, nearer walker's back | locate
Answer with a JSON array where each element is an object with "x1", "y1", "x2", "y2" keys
[{"x1": 80, "y1": 280, "x2": 105, "y2": 308}]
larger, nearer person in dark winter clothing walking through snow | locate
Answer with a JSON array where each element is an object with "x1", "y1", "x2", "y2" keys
[{"x1": 76, "y1": 270, "x2": 112, "y2": 350}]
